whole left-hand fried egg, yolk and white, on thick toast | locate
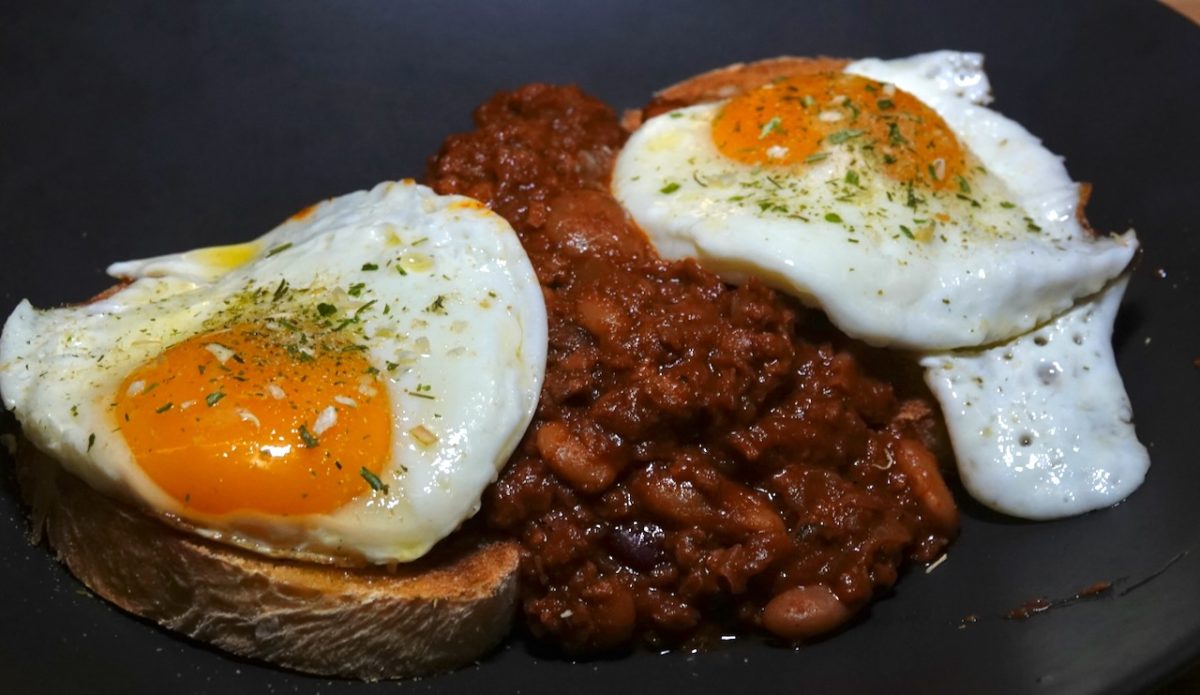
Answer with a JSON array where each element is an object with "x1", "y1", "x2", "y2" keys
[{"x1": 0, "y1": 181, "x2": 546, "y2": 563}]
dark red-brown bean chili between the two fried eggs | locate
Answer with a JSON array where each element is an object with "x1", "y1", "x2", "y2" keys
[{"x1": 428, "y1": 84, "x2": 958, "y2": 652}]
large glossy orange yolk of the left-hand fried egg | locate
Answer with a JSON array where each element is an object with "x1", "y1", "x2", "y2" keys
[{"x1": 114, "y1": 324, "x2": 391, "y2": 515}]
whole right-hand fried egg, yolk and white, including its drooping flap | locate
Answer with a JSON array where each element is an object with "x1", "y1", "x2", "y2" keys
[{"x1": 612, "y1": 52, "x2": 1148, "y2": 519}]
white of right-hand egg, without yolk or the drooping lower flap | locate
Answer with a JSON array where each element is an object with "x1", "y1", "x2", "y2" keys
[{"x1": 612, "y1": 53, "x2": 1138, "y2": 349}]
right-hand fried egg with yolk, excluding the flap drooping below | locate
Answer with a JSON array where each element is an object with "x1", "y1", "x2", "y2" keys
[{"x1": 613, "y1": 54, "x2": 1136, "y2": 349}]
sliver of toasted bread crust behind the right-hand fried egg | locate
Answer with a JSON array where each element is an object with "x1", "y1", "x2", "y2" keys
[{"x1": 622, "y1": 55, "x2": 851, "y2": 132}]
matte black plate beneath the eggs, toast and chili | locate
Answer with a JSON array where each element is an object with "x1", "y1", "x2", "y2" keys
[{"x1": 0, "y1": 0, "x2": 1200, "y2": 693}]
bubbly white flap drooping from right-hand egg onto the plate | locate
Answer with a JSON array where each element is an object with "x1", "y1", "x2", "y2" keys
[{"x1": 920, "y1": 276, "x2": 1150, "y2": 520}]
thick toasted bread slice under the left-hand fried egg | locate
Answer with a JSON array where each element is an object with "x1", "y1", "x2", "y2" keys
[{"x1": 17, "y1": 442, "x2": 518, "y2": 681}]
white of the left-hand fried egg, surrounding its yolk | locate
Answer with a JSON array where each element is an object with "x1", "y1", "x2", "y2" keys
[{"x1": 0, "y1": 181, "x2": 546, "y2": 563}]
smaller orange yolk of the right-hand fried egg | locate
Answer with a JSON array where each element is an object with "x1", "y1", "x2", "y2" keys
[{"x1": 713, "y1": 72, "x2": 966, "y2": 190}]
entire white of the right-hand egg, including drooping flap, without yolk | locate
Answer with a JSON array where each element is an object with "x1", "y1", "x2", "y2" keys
[{"x1": 612, "y1": 50, "x2": 1150, "y2": 519}]
